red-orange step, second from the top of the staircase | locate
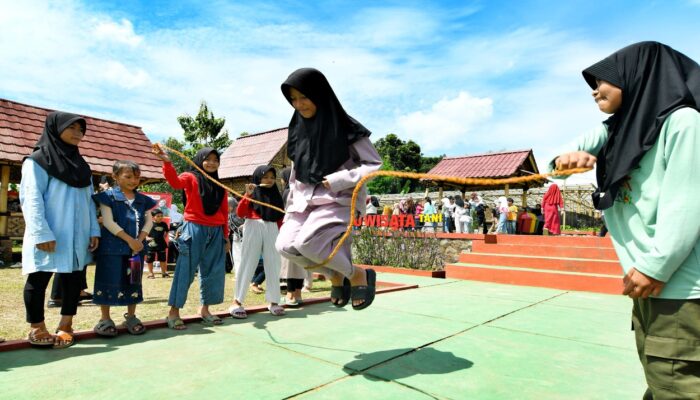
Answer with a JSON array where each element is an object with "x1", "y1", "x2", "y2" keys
[{"x1": 472, "y1": 241, "x2": 618, "y2": 261}]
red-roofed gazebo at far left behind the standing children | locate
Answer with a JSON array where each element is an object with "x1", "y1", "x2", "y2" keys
[{"x1": 0, "y1": 98, "x2": 163, "y2": 258}]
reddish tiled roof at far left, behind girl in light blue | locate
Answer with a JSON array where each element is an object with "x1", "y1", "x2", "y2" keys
[{"x1": 0, "y1": 98, "x2": 163, "y2": 179}]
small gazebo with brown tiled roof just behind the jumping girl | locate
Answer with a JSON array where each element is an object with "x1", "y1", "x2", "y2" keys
[{"x1": 219, "y1": 128, "x2": 292, "y2": 192}]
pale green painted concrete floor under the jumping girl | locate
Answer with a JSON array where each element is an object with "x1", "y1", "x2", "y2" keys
[{"x1": 0, "y1": 274, "x2": 646, "y2": 400}]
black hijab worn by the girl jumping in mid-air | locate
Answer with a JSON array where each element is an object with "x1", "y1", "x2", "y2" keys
[{"x1": 282, "y1": 68, "x2": 371, "y2": 184}]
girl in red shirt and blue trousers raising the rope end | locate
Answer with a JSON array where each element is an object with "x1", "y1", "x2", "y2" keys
[{"x1": 153, "y1": 145, "x2": 231, "y2": 330}]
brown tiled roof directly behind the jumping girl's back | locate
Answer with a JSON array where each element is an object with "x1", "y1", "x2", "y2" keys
[{"x1": 219, "y1": 128, "x2": 287, "y2": 179}]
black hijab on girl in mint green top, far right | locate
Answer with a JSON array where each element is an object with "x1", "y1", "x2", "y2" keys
[{"x1": 583, "y1": 42, "x2": 700, "y2": 210}]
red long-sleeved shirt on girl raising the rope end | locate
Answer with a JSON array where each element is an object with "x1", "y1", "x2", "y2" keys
[{"x1": 163, "y1": 162, "x2": 228, "y2": 238}]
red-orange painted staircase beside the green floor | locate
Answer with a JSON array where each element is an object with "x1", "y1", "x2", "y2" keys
[{"x1": 445, "y1": 235, "x2": 623, "y2": 294}]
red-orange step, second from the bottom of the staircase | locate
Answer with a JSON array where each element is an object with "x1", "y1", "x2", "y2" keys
[{"x1": 459, "y1": 253, "x2": 622, "y2": 274}]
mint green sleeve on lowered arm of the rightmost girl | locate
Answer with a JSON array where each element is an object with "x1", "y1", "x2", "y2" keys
[{"x1": 636, "y1": 108, "x2": 700, "y2": 282}]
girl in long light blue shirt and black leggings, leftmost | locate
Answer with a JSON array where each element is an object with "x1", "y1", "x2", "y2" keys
[{"x1": 20, "y1": 112, "x2": 100, "y2": 348}]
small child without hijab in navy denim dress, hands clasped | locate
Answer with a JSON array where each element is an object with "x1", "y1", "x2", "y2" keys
[{"x1": 92, "y1": 161, "x2": 156, "y2": 336}]
